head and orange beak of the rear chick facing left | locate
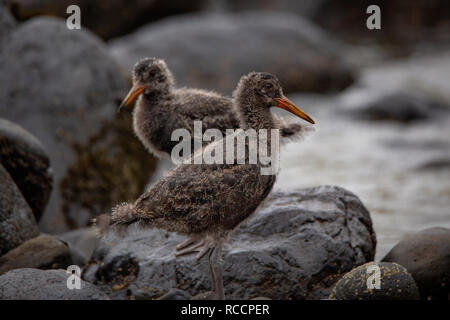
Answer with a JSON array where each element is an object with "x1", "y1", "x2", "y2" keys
[{"x1": 119, "y1": 58, "x2": 174, "y2": 111}]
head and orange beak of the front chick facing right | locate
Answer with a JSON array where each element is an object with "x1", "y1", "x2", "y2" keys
[{"x1": 233, "y1": 72, "x2": 315, "y2": 124}]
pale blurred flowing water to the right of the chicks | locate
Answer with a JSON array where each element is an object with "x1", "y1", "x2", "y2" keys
[{"x1": 275, "y1": 53, "x2": 450, "y2": 260}]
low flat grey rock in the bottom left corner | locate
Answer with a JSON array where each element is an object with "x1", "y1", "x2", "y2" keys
[{"x1": 0, "y1": 268, "x2": 108, "y2": 300}]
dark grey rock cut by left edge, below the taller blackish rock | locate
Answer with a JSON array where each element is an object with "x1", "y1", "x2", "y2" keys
[{"x1": 0, "y1": 164, "x2": 39, "y2": 255}]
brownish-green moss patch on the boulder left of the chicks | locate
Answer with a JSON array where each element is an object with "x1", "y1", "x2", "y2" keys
[{"x1": 59, "y1": 112, "x2": 157, "y2": 228}]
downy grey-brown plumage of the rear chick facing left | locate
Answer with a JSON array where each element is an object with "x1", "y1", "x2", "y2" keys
[{"x1": 128, "y1": 58, "x2": 305, "y2": 157}]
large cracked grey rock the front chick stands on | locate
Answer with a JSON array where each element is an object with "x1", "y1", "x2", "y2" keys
[{"x1": 84, "y1": 186, "x2": 376, "y2": 299}]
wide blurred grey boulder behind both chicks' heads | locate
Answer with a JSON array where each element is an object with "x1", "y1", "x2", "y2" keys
[{"x1": 111, "y1": 12, "x2": 353, "y2": 94}]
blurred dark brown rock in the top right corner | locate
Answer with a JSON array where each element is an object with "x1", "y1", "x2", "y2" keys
[{"x1": 310, "y1": 0, "x2": 450, "y2": 46}]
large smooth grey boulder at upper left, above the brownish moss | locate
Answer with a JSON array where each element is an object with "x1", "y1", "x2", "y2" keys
[{"x1": 0, "y1": 18, "x2": 127, "y2": 232}]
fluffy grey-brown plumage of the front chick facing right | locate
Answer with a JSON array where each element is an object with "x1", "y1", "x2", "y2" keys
[{"x1": 110, "y1": 73, "x2": 290, "y2": 240}]
